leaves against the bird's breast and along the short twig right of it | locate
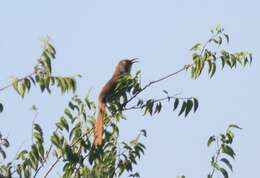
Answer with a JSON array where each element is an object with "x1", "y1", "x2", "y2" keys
[{"x1": 114, "y1": 71, "x2": 199, "y2": 117}]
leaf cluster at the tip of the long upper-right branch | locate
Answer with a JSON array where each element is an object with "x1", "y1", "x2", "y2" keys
[{"x1": 189, "y1": 26, "x2": 252, "y2": 79}]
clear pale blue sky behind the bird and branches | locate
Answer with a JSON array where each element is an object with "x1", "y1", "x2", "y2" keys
[{"x1": 0, "y1": 0, "x2": 260, "y2": 178}]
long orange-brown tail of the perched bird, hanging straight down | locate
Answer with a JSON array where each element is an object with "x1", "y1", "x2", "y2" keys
[{"x1": 94, "y1": 102, "x2": 105, "y2": 145}]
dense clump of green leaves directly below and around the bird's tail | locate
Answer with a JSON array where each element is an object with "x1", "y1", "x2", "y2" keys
[{"x1": 48, "y1": 96, "x2": 146, "y2": 177}]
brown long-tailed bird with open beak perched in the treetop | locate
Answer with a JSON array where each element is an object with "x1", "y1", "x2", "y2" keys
[{"x1": 94, "y1": 58, "x2": 138, "y2": 146}]
